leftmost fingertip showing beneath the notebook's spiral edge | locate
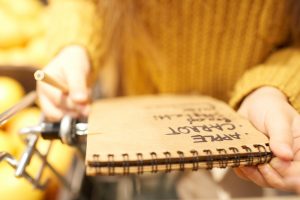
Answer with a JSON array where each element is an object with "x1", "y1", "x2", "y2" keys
[{"x1": 240, "y1": 167, "x2": 269, "y2": 187}]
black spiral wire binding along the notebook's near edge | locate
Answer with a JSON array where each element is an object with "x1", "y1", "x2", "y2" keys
[{"x1": 89, "y1": 144, "x2": 273, "y2": 175}]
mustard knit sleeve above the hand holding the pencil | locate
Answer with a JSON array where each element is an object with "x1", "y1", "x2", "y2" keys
[{"x1": 45, "y1": 0, "x2": 102, "y2": 74}]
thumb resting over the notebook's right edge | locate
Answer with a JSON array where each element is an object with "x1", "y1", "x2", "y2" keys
[{"x1": 265, "y1": 110, "x2": 293, "y2": 160}]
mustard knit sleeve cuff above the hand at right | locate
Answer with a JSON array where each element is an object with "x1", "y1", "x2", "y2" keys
[{"x1": 229, "y1": 48, "x2": 300, "y2": 112}]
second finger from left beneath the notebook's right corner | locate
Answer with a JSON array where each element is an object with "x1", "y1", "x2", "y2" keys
[{"x1": 258, "y1": 164, "x2": 287, "y2": 190}]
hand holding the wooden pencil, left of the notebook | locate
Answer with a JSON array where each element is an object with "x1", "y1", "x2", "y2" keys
[{"x1": 37, "y1": 46, "x2": 90, "y2": 121}]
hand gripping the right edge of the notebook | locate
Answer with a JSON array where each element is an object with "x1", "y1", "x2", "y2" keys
[{"x1": 235, "y1": 87, "x2": 300, "y2": 190}]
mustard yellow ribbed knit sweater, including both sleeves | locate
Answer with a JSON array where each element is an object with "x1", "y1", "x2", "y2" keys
[{"x1": 48, "y1": 0, "x2": 300, "y2": 111}]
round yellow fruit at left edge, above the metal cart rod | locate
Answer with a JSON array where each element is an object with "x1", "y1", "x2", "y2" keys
[{"x1": 0, "y1": 76, "x2": 25, "y2": 113}]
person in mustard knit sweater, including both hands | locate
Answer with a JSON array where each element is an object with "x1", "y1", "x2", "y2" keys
[{"x1": 38, "y1": 0, "x2": 300, "y2": 196}]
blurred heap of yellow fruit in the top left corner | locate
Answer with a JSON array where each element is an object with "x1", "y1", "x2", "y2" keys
[{"x1": 0, "y1": 0, "x2": 47, "y2": 67}]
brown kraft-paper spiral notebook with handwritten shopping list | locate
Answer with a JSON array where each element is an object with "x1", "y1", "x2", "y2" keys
[{"x1": 86, "y1": 95, "x2": 272, "y2": 175}]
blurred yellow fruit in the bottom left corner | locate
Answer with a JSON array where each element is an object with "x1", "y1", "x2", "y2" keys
[{"x1": 0, "y1": 164, "x2": 44, "y2": 200}]
